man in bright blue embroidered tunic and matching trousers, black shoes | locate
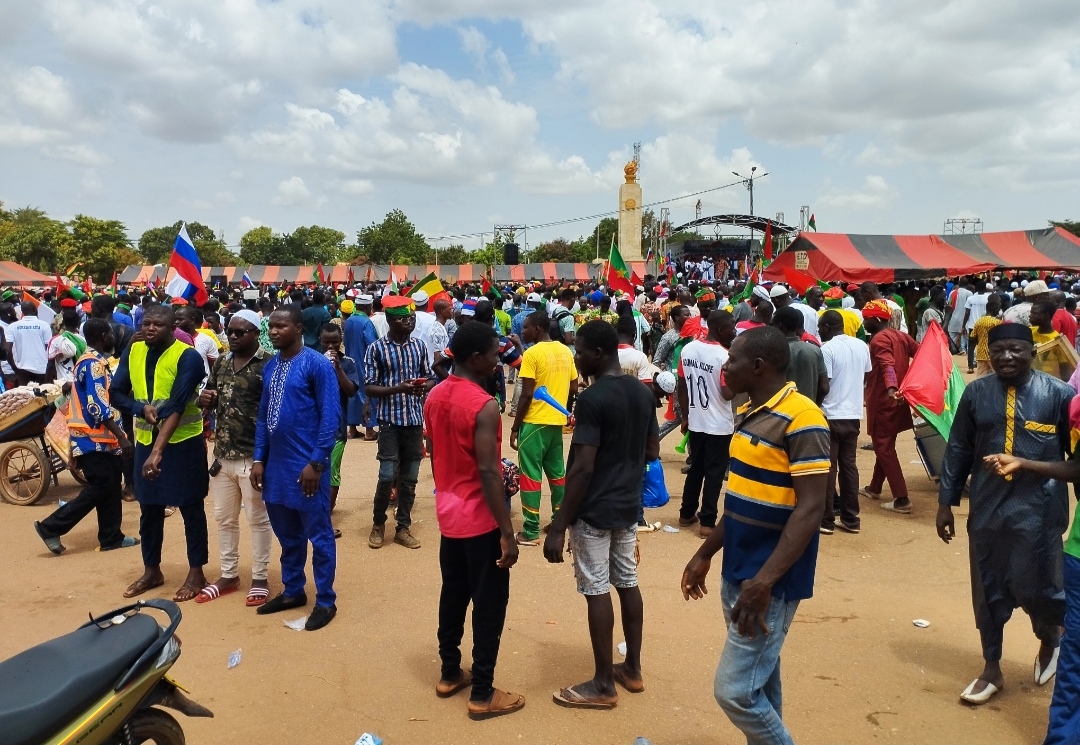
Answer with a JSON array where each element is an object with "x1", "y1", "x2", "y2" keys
[{"x1": 252, "y1": 304, "x2": 342, "y2": 632}]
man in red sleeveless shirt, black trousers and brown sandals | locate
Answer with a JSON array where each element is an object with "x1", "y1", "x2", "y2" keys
[{"x1": 423, "y1": 322, "x2": 525, "y2": 719}]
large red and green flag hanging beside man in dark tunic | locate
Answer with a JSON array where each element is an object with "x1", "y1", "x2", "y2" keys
[{"x1": 900, "y1": 321, "x2": 963, "y2": 441}]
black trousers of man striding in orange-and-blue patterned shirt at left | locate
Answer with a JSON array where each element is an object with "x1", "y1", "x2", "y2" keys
[{"x1": 41, "y1": 452, "x2": 124, "y2": 548}]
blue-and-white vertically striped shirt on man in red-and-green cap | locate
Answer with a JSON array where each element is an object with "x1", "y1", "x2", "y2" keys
[{"x1": 364, "y1": 335, "x2": 431, "y2": 426}]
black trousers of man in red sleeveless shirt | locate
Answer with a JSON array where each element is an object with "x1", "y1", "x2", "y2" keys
[{"x1": 438, "y1": 530, "x2": 510, "y2": 701}]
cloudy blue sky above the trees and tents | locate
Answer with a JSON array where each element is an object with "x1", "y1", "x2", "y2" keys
[{"x1": 0, "y1": 0, "x2": 1080, "y2": 248}]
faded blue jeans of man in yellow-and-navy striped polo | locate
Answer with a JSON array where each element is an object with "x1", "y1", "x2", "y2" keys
[{"x1": 713, "y1": 580, "x2": 799, "y2": 745}]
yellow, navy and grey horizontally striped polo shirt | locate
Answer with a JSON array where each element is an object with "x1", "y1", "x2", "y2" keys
[{"x1": 721, "y1": 383, "x2": 829, "y2": 600}]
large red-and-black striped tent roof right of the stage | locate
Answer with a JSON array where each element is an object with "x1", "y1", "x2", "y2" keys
[{"x1": 765, "y1": 228, "x2": 1080, "y2": 284}]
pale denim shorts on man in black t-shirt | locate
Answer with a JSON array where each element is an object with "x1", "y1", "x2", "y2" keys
[{"x1": 570, "y1": 520, "x2": 637, "y2": 595}]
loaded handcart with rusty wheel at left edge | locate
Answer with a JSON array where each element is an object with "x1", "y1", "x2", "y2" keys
[{"x1": 0, "y1": 395, "x2": 85, "y2": 505}]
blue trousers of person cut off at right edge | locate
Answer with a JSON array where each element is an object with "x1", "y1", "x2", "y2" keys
[{"x1": 1043, "y1": 554, "x2": 1080, "y2": 745}]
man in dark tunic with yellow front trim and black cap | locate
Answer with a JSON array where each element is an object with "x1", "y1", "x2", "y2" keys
[{"x1": 937, "y1": 323, "x2": 1075, "y2": 705}]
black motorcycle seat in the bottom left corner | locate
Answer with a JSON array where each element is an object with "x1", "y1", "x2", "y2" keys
[{"x1": 0, "y1": 613, "x2": 161, "y2": 745}]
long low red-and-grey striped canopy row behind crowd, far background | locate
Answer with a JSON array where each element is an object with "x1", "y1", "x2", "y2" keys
[{"x1": 119, "y1": 261, "x2": 647, "y2": 287}]
